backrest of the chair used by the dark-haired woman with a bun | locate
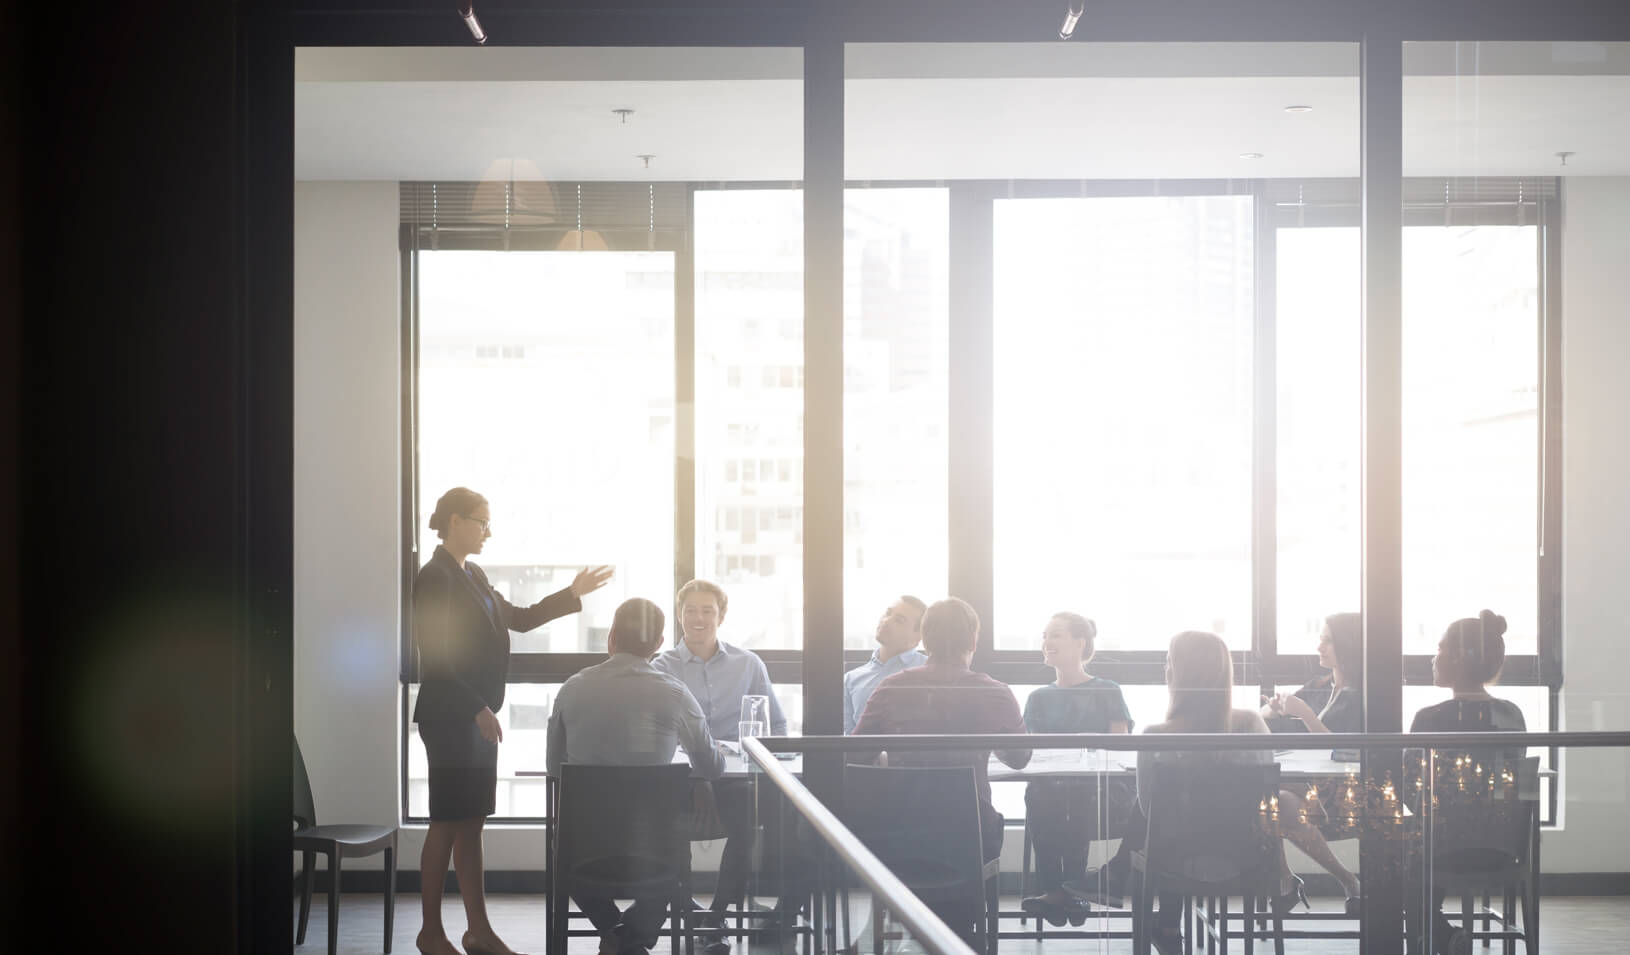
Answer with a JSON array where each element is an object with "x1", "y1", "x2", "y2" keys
[{"x1": 1431, "y1": 750, "x2": 1539, "y2": 870}]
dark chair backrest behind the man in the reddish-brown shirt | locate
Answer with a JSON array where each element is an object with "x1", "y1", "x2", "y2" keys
[{"x1": 843, "y1": 766, "x2": 985, "y2": 896}]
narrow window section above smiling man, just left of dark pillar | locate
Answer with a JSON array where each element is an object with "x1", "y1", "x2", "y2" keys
[{"x1": 694, "y1": 189, "x2": 804, "y2": 650}]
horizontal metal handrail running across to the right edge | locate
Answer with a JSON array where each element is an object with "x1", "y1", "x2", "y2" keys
[{"x1": 758, "y1": 732, "x2": 1630, "y2": 753}]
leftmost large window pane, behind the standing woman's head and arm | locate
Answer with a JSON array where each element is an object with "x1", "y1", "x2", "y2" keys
[{"x1": 414, "y1": 251, "x2": 673, "y2": 652}]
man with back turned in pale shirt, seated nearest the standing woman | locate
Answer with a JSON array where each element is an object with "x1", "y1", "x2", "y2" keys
[{"x1": 548, "y1": 596, "x2": 724, "y2": 955}]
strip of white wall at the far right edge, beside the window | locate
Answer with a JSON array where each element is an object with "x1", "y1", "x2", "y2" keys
[{"x1": 1544, "y1": 176, "x2": 1630, "y2": 872}]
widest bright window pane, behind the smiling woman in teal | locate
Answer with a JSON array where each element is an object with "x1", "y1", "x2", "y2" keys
[{"x1": 994, "y1": 196, "x2": 1253, "y2": 650}]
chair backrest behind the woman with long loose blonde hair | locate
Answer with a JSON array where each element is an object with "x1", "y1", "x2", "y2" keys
[{"x1": 1146, "y1": 759, "x2": 1280, "y2": 885}]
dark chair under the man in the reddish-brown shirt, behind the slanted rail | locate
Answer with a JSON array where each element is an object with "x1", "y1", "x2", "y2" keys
[{"x1": 843, "y1": 766, "x2": 1001, "y2": 952}]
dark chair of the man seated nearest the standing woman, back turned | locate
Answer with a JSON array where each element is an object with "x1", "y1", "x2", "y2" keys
[{"x1": 549, "y1": 763, "x2": 691, "y2": 955}]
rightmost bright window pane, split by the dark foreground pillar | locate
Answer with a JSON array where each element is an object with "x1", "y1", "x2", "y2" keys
[{"x1": 1276, "y1": 225, "x2": 1540, "y2": 655}]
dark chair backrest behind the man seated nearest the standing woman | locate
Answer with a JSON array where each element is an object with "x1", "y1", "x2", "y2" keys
[{"x1": 556, "y1": 763, "x2": 691, "y2": 874}]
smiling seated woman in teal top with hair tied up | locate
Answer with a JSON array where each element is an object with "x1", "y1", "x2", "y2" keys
[{"x1": 1020, "y1": 613, "x2": 1136, "y2": 926}]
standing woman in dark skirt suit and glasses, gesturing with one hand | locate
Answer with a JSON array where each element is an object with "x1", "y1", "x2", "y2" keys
[{"x1": 412, "y1": 487, "x2": 611, "y2": 955}]
